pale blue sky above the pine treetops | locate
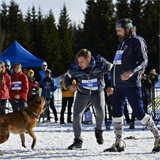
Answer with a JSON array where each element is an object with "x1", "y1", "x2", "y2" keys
[{"x1": 3, "y1": 0, "x2": 115, "y2": 24}]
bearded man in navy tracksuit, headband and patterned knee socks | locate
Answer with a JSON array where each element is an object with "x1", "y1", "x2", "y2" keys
[{"x1": 104, "y1": 18, "x2": 160, "y2": 152}]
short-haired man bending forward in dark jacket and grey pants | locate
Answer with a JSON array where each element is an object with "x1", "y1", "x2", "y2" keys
[{"x1": 65, "y1": 49, "x2": 112, "y2": 149}]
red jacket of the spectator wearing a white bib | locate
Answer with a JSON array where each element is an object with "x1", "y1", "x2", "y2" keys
[{"x1": 9, "y1": 72, "x2": 29, "y2": 102}]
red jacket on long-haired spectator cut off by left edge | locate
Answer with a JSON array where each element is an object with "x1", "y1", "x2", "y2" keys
[{"x1": 0, "y1": 71, "x2": 12, "y2": 100}]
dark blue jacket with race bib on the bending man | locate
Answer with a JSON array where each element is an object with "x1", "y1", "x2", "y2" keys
[{"x1": 64, "y1": 54, "x2": 112, "y2": 95}]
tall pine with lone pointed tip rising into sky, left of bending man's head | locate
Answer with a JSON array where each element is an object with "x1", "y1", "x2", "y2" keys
[{"x1": 58, "y1": 5, "x2": 74, "y2": 71}]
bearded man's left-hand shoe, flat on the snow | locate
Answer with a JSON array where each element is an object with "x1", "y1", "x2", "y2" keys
[{"x1": 104, "y1": 141, "x2": 125, "y2": 152}]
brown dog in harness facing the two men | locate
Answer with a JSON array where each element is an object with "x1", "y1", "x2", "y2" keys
[{"x1": 0, "y1": 97, "x2": 45, "y2": 155}]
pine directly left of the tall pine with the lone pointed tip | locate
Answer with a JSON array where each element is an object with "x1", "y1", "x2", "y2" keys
[{"x1": 42, "y1": 10, "x2": 63, "y2": 77}]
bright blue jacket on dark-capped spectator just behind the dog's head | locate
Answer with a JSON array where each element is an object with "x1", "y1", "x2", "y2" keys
[{"x1": 40, "y1": 77, "x2": 57, "y2": 99}]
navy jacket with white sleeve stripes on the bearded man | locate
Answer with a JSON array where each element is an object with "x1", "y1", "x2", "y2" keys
[{"x1": 111, "y1": 35, "x2": 148, "y2": 88}]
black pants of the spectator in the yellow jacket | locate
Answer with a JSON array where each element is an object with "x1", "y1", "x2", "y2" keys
[{"x1": 60, "y1": 97, "x2": 74, "y2": 122}]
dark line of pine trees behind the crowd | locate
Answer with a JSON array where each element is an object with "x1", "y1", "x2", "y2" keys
[{"x1": 0, "y1": 0, "x2": 160, "y2": 76}]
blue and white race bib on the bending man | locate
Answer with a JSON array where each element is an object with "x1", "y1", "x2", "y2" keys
[{"x1": 82, "y1": 78, "x2": 98, "y2": 90}]
